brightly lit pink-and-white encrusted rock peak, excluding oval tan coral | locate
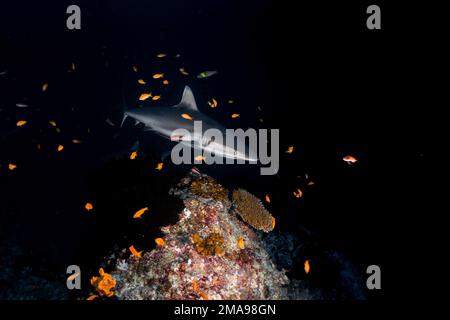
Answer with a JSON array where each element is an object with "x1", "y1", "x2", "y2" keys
[{"x1": 112, "y1": 174, "x2": 289, "y2": 300}]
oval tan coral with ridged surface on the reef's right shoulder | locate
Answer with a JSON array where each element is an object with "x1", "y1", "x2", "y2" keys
[{"x1": 233, "y1": 189, "x2": 275, "y2": 232}]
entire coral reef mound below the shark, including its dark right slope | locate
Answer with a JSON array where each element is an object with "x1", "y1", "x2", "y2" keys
[{"x1": 89, "y1": 172, "x2": 365, "y2": 300}]
